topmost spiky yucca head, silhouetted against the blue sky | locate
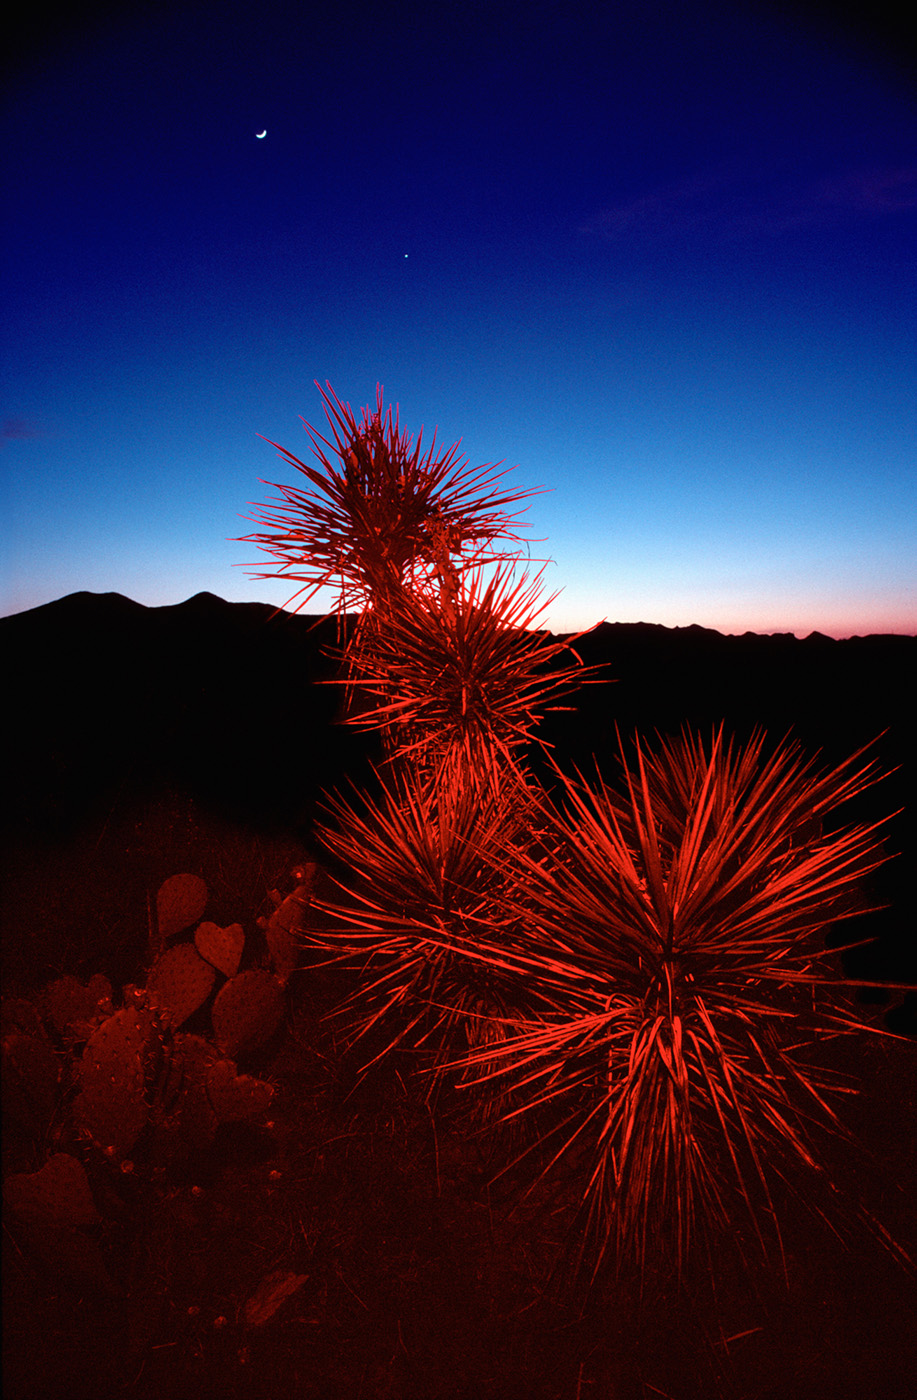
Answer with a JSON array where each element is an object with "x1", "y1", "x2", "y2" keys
[{"x1": 236, "y1": 384, "x2": 540, "y2": 613}]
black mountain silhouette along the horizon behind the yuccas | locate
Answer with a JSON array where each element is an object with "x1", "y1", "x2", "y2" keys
[{"x1": 0, "y1": 592, "x2": 917, "y2": 1029}]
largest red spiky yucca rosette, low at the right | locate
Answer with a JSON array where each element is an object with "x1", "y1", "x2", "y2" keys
[{"x1": 434, "y1": 732, "x2": 907, "y2": 1267}]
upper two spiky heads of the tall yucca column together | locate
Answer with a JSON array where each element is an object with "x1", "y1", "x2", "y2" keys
[{"x1": 236, "y1": 385, "x2": 578, "y2": 770}]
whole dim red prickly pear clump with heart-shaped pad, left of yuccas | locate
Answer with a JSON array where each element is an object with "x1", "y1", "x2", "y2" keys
[{"x1": 0, "y1": 851, "x2": 293, "y2": 1315}]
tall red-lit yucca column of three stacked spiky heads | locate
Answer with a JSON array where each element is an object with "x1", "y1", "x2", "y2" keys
[{"x1": 248, "y1": 386, "x2": 602, "y2": 1103}]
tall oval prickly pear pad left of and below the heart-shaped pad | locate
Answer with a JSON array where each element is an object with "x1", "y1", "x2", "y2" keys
[{"x1": 73, "y1": 1004, "x2": 155, "y2": 1158}]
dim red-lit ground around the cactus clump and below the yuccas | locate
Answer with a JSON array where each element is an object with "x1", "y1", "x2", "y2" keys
[{"x1": 3, "y1": 792, "x2": 917, "y2": 1400}]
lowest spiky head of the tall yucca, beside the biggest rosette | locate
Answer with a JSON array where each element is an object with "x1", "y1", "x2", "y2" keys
[{"x1": 305, "y1": 767, "x2": 551, "y2": 1097}]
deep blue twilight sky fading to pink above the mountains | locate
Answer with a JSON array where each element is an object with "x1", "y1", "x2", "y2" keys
[{"x1": 0, "y1": 0, "x2": 917, "y2": 636}]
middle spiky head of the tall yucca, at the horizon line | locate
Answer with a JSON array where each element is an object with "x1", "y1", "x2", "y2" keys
[{"x1": 344, "y1": 564, "x2": 598, "y2": 790}]
